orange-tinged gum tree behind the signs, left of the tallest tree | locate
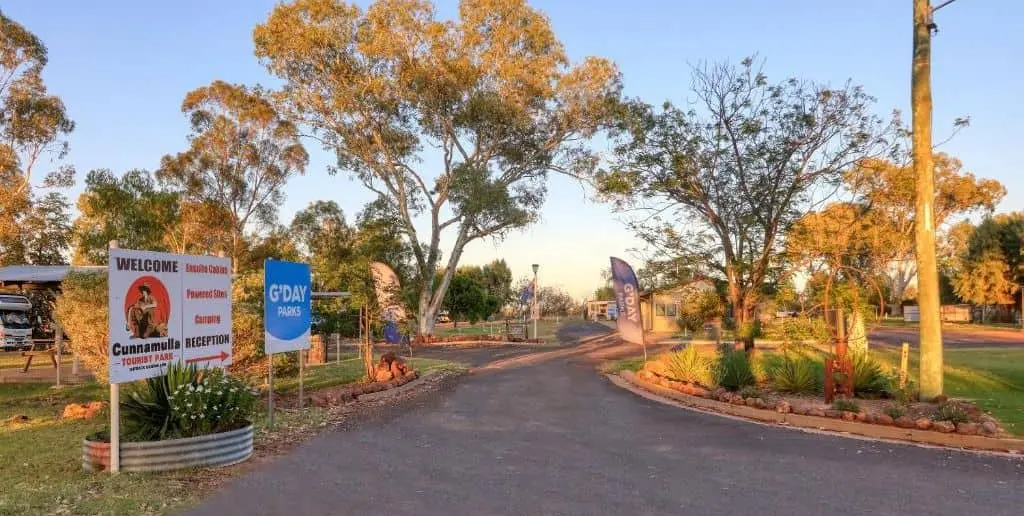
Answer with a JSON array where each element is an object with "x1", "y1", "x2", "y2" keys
[{"x1": 157, "y1": 81, "x2": 309, "y2": 271}]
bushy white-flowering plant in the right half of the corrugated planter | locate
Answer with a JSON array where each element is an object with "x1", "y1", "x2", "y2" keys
[{"x1": 168, "y1": 369, "x2": 256, "y2": 436}]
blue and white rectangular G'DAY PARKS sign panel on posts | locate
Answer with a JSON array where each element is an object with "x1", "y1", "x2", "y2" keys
[{"x1": 263, "y1": 260, "x2": 312, "y2": 354}]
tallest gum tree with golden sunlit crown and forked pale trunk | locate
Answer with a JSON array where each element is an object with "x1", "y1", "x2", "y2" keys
[{"x1": 253, "y1": 0, "x2": 621, "y2": 334}]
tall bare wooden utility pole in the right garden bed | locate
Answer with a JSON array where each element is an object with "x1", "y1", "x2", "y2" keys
[{"x1": 910, "y1": 0, "x2": 942, "y2": 400}]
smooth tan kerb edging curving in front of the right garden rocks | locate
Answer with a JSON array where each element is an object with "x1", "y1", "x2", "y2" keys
[{"x1": 608, "y1": 371, "x2": 1024, "y2": 455}]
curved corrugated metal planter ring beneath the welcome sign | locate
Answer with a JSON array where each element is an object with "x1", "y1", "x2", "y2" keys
[{"x1": 82, "y1": 425, "x2": 253, "y2": 472}]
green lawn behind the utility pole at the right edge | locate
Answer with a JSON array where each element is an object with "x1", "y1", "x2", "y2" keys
[{"x1": 872, "y1": 348, "x2": 1024, "y2": 436}]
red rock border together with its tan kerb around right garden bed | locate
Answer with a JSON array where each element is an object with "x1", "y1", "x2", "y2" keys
[{"x1": 609, "y1": 371, "x2": 1024, "y2": 454}]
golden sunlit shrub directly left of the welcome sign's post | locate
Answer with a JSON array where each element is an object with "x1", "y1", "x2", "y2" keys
[{"x1": 53, "y1": 271, "x2": 110, "y2": 383}]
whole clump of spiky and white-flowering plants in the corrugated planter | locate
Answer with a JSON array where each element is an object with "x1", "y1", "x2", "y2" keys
[{"x1": 121, "y1": 362, "x2": 256, "y2": 441}]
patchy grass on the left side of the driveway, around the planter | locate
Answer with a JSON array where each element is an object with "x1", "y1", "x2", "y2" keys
[{"x1": 0, "y1": 356, "x2": 462, "y2": 514}]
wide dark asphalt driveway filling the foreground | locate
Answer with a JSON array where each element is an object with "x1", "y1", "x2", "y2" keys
[{"x1": 193, "y1": 323, "x2": 1024, "y2": 516}]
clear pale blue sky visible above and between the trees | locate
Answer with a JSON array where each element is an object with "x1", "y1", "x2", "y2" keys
[{"x1": 3, "y1": 0, "x2": 1024, "y2": 297}]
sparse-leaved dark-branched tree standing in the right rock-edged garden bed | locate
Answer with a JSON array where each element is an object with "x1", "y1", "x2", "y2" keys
[{"x1": 597, "y1": 58, "x2": 892, "y2": 349}]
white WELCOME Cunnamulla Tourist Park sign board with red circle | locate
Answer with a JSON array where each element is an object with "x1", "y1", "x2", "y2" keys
[{"x1": 109, "y1": 249, "x2": 231, "y2": 383}]
